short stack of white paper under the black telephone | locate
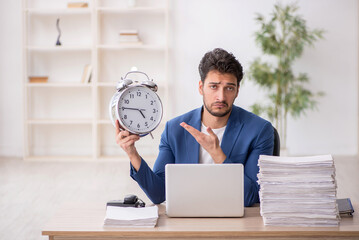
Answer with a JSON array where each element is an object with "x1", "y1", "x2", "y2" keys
[{"x1": 104, "y1": 205, "x2": 158, "y2": 227}]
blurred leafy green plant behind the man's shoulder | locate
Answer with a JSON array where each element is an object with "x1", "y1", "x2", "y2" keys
[{"x1": 248, "y1": 3, "x2": 323, "y2": 149}]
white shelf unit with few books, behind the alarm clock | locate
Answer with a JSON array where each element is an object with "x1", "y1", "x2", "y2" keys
[{"x1": 22, "y1": 0, "x2": 170, "y2": 161}]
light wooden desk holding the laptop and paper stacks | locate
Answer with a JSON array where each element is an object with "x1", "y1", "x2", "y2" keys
[{"x1": 42, "y1": 204, "x2": 359, "y2": 240}]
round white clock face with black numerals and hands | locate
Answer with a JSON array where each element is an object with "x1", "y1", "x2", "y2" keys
[{"x1": 117, "y1": 86, "x2": 162, "y2": 134}]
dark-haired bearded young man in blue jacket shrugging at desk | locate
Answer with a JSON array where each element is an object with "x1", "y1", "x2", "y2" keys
[{"x1": 116, "y1": 48, "x2": 274, "y2": 206}]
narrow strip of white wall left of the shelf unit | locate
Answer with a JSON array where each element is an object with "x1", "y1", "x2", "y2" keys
[{"x1": 0, "y1": 0, "x2": 23, "y2": 156}]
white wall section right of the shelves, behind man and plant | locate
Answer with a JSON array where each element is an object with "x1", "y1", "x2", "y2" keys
[{"x1": 171, "y1": 0, "x2": 358, "y2": 155}]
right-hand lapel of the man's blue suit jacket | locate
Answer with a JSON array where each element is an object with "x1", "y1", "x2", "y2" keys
[{"x1": 221, "y1": 106, "x2": 243, "y2": 158}]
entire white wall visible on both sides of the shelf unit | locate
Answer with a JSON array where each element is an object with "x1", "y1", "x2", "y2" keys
[{"x1": 0, "y1": 0, "x2": 358, "y2": 156}]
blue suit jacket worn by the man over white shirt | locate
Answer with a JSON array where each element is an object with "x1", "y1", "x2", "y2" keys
[{"x1": 130, "y1": 106, "x2": 274, "y2": 206}]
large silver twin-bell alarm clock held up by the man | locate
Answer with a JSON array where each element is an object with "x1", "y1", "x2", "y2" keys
[{"x1": 110, "y1": 71, "x2": 163, "y2": 137}]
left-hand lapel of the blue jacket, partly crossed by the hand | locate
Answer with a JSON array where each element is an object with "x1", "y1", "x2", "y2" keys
[{"x1": 185, "y1": 108, "x2": 202, "y2": 163}]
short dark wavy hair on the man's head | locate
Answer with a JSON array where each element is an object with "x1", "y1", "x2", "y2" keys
[{"x1": 198, "y1": 48, "x2": 243, "y2": 86}]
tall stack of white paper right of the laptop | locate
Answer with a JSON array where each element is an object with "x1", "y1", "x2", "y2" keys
[{"x1": 258, "y1": 155, "x2": 339, "y2": 226}]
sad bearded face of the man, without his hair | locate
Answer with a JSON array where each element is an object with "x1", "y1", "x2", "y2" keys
[{"x1": 199, "y1": 70, "x2": 239, "y2": 117}]
